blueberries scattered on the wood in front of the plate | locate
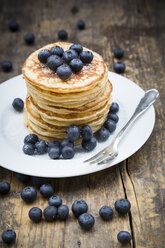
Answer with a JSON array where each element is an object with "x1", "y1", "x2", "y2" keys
[{"x1": 0, "y1": 177, "x2": 131, "y2": 244}]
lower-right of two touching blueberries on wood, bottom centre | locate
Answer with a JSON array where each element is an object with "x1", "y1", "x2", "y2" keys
[{"x1": 78, "y1": 213, "x2": 95, "y2": 230}]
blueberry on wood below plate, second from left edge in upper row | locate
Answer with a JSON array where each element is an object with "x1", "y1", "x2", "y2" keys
[{"x1": 21, "y1": 186, "x2": 37, "y2": 203}]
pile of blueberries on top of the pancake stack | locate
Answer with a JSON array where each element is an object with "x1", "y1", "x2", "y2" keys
[{"x1": 38, "y1": 44, "x2": 93, "y2": 80}]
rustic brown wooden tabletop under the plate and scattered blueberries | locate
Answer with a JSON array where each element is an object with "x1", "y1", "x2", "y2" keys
[{"x1": 0, "y1": 0, "x2": 165, "y2": 248}]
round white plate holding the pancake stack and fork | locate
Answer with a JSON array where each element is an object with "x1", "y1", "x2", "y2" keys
[{"x1": 0, "y1": 72, "x2": 155, "y2": 178}]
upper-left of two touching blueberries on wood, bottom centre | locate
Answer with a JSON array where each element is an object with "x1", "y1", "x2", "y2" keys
[{"x1": 72, "y1": 200, "x2": 88, "y2": 217}]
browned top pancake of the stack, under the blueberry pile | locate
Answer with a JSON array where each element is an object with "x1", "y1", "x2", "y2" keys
[{"x1": 22, "y1": 42, "x2": 108, "y2": 93}]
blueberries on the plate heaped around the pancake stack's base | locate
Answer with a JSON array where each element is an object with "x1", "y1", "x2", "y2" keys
[{"x1": 20, "y1": 102, "x2": 119, "y2": 159}]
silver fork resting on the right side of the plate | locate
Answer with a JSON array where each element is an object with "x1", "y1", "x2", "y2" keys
[{"x1": 84, "y1": 89, "x2": 159, "y2": 165}]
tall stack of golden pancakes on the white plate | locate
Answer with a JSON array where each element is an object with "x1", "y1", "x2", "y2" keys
[{"x1": 22, "y1": 42, "x2": 112, "y2": 141}]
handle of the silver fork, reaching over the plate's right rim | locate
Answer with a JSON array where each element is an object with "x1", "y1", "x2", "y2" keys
[{"x1": 114, "y1": 89, "x2": 159, "y2": 144}]
